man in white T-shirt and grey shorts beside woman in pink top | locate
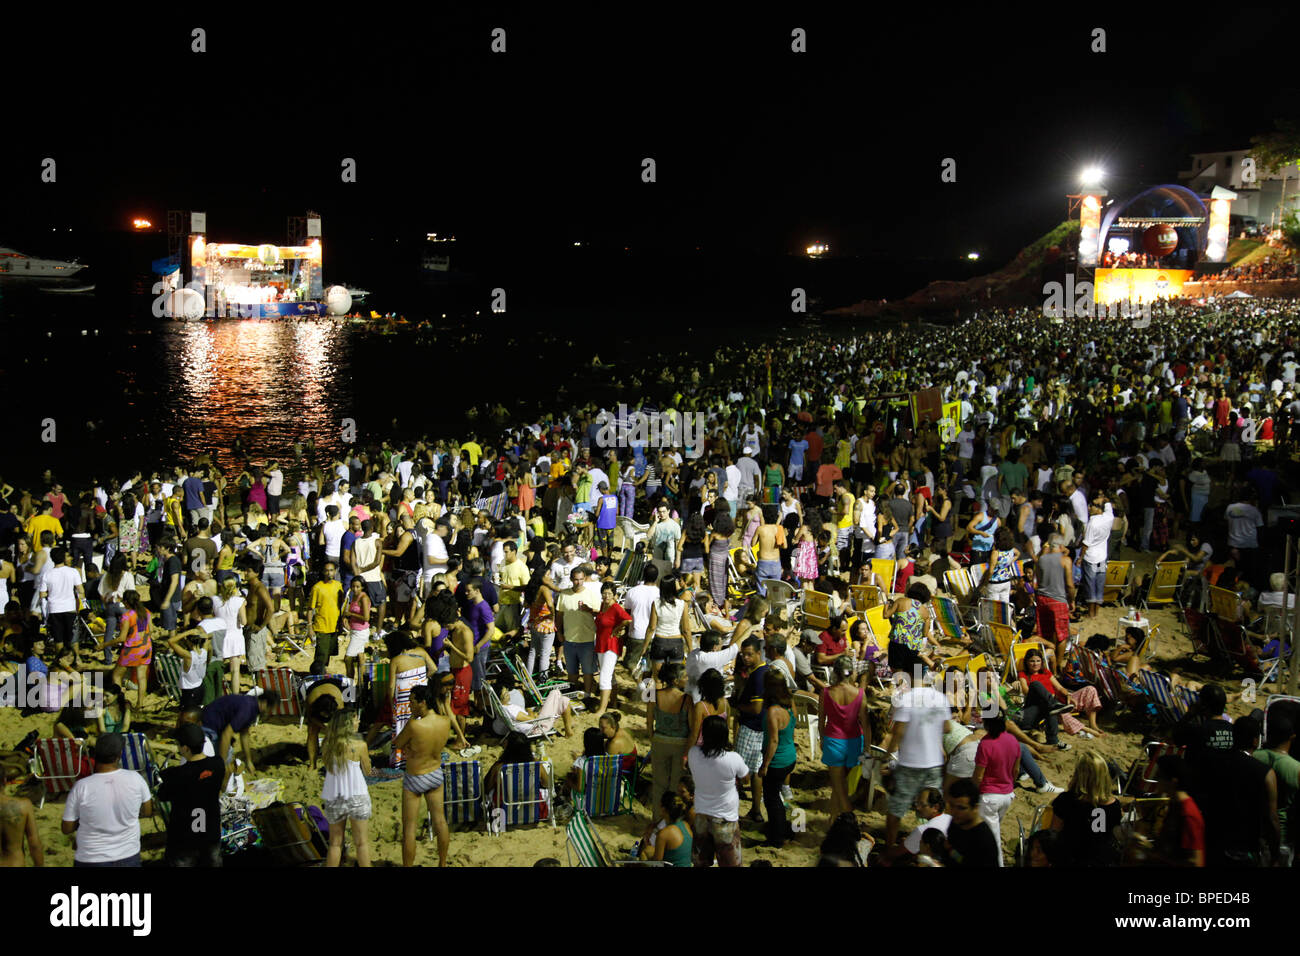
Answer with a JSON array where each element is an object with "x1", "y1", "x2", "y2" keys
[{"x1": 885, "y1": 684, "x2": 953, "y2": 847}]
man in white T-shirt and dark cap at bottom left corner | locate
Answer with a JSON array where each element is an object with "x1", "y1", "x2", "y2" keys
[{"x1": 61, "y1": 734, "x2": 153, "y2": 868}]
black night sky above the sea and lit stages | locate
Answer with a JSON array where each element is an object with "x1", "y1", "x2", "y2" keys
[{"x1": 0, "y1": 4, "x2": 1300, "y2": 260}]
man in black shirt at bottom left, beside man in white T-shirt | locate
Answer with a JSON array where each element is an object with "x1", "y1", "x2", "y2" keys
[{"x1": 157, "y1": 723, "x2": 226, "y2": 866}]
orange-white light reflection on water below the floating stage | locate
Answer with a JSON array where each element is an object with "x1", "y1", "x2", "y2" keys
[{"x1": 159, "y1": 319, "x2": 352, "y2": 460}]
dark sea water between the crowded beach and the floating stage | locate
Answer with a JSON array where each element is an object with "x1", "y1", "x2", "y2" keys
[{"x1": 0, "y1": 247, "x2": 977, "y2": 481}]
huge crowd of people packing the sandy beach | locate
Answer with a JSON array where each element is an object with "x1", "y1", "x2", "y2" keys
[{"x1": 0, "y1": 299, "x2": 1300, "y2": 866}]
